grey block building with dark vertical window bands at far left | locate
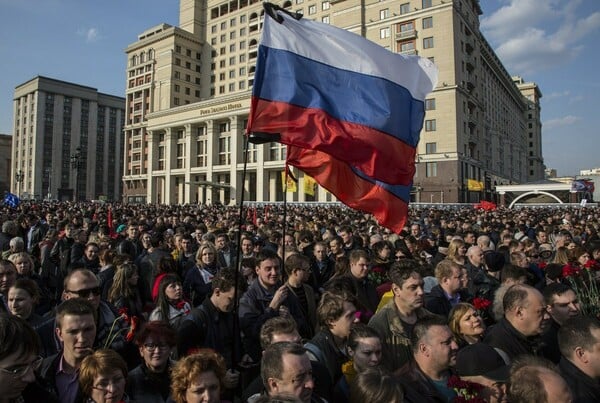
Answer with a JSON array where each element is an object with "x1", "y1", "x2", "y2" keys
[{"x1": 10, "y1": 76, "x2": 125, "y2": 201}]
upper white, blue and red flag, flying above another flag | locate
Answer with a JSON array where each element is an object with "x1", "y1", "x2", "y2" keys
[{"x1": 248, "y1": 6, "x2": 437, "y2": 185}]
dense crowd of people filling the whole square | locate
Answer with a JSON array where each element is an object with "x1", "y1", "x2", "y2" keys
[{"x1": 0, "y1": 202, "x2": 600, "y2": 403}]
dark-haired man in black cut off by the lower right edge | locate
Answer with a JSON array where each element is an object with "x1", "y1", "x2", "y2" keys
[{"x1": 558, "y1": 317, "x2": 600, "y2": 403}]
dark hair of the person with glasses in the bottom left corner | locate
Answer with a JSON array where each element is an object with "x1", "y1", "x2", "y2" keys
[{"x1": 0, "y1": 313, "x2": 40, "y2": 360}]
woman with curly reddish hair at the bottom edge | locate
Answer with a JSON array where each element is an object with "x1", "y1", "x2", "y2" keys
[{"x1": 171, "y1": 349, "x2": 226, "y2": 403}]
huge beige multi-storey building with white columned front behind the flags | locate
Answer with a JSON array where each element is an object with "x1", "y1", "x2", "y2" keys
[{"x1": 123, "y1": 0, "x2": 544, "y2": 204}]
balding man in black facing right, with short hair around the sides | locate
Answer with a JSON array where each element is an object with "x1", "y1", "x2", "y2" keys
[{"x1": 484, "y1": 284, "x2": 550, "y2": 361}]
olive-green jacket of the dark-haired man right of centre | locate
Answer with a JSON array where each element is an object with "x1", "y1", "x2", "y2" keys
[{"x1": 369, "y1": 299, "x2": 435, "y2": 372}]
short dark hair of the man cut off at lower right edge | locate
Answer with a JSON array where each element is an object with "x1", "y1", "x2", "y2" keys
[{"x1": 558, "y1": 316, "x2": 600, "y2": 358}]
